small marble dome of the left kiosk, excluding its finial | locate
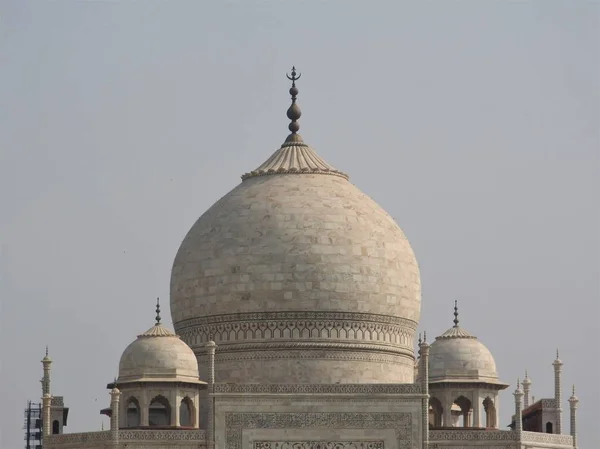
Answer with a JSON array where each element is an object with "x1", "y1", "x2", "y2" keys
[{"x1": 117, "y1": 323, "x2": 203, "y2": 383}]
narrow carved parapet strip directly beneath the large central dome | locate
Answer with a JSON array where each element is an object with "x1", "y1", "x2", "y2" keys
[{"x1": 214, "y1": 383, "x2": 421, "y2": 395}]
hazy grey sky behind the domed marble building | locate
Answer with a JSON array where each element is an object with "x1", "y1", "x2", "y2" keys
[{"x1": 0, "y1": 0, "x2": 600, "y2": 449}]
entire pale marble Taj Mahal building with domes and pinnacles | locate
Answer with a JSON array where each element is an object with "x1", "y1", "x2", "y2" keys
[{"x1": 42, "y1": 69, "x2": 578, "y2": 449}]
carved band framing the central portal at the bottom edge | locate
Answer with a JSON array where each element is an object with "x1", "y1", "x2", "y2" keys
[{"x1": 225, "y1": 412, "x2": 413, "y2": 449}]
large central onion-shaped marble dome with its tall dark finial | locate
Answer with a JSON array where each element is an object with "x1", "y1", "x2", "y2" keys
[{"x1": 171, "y1": 69, "x2": 421, "y2": 383}]
